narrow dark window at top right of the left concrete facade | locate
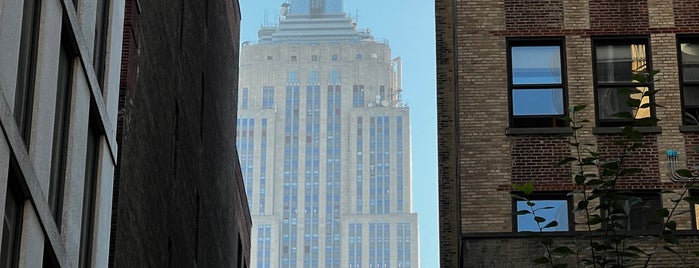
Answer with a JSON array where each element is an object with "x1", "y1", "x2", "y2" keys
[{"x1": 92, "y1": 0, "x2": 109, "y2": 92}]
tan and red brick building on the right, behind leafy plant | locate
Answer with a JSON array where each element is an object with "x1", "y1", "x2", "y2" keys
[{"x1": 435, "y1": 0, "x2": 699, "y2": 267}]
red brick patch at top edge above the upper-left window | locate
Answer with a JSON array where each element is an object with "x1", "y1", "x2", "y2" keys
[{"x1": 505, "y1": 0, "x2": 563, "y2": 30}]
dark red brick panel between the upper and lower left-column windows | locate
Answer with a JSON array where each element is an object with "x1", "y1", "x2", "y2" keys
[{"x1": 510, "y1": 136, "x2": 571, "y2": 184}]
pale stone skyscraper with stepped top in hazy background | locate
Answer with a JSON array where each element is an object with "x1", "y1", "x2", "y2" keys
[{"x1": 237, "y1": 0, "x2": 419, "y2": 267}]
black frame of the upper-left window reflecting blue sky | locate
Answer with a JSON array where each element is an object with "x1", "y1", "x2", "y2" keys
[{"x1": 506, "y1": 37, "x2": 568, "y2": 129}]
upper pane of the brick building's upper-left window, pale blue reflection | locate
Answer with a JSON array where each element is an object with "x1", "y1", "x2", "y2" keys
[{"x1": 512, "y1": 46, "x2": 561, "y2": 85}]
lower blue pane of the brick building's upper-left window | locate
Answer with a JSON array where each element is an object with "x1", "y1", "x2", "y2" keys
[{"x1": 512, "y1": 88, "x2": 563, "y2": 115}]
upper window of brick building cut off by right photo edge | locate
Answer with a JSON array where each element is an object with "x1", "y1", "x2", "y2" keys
[{"x1": 677, "y1": 36, "x2": 699, "y2": 125}]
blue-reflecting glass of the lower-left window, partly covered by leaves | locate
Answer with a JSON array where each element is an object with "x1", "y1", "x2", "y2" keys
[{"x1": 517, "y1": 200, "x2": 570, "y2": 232}]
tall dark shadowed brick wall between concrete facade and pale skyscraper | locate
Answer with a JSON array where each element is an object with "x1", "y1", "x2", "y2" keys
[{"x1": 110, "y1": 0, "x2": 251, "y2": 267}]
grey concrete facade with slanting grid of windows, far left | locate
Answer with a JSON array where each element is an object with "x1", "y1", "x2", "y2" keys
[{"x1": 0, "y1": 0, "x2": 124, "y2": 267}]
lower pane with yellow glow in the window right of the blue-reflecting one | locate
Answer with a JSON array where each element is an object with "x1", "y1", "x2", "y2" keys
[{"x1": 597, "y1": 87, "x2": 650, "y2": 119}]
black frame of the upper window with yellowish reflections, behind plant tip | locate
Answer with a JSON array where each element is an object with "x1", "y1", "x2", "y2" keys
[{"x1": 590, "y1": 35, "x2": 655, "y2": 127}]
